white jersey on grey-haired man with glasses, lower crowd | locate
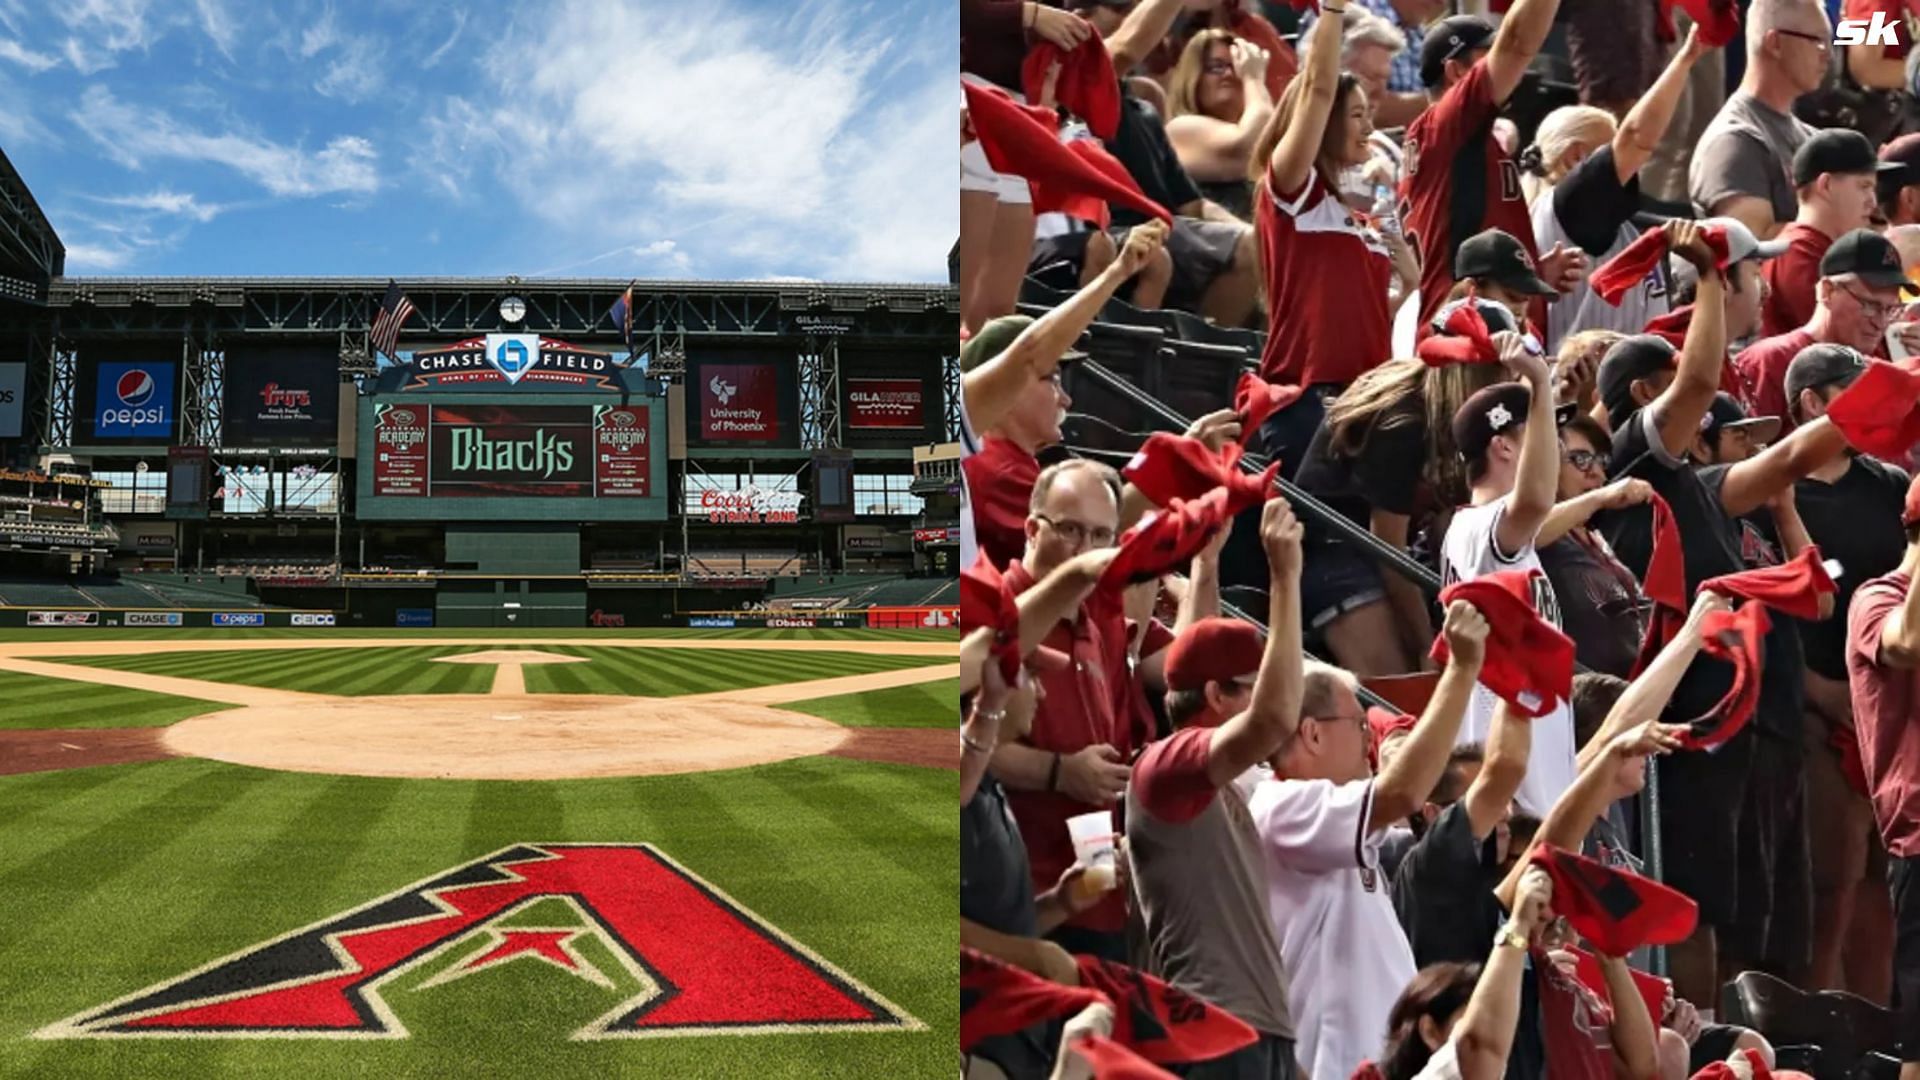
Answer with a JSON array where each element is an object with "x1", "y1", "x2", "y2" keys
[{"x1": 1248, "y1": 780, "x2": 1417, "y2": 1080}]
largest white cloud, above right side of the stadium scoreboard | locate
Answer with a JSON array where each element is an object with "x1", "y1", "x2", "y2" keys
[{"x1": 417, "y1": 0, "x2": 958, "y2": 281}]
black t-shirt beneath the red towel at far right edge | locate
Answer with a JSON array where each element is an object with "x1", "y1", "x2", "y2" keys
[{"x1": 1793, "y1": 454, "x2": 1907, "y2": 680}]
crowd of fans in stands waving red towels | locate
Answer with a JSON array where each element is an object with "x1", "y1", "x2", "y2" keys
[{"x1": 958, "y1": 0, "x2": 1920, "y2": 1080}]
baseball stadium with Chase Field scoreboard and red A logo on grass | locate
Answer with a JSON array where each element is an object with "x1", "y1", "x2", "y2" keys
[{"x1": 0, "y1": 145, "x2": 958, "y2": 1078}]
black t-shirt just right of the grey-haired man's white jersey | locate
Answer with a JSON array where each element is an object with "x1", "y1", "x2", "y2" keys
[{"x1": 1392, "y1": 799, "x2": 1501, "y2": 967}]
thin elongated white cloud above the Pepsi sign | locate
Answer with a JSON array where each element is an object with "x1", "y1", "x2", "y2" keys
[{"x1": 73, "y1": 86, "x2": 380, "y2": 196}]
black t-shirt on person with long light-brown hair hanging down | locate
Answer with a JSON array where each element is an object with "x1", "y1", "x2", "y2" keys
[{"x1": 1294, "y1": 400, "x2": 1427, "y2": 544}]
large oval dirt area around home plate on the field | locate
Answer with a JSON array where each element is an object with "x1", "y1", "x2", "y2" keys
[{"x1": 165, "y1": 691, "x2": 847, "y2": 780}]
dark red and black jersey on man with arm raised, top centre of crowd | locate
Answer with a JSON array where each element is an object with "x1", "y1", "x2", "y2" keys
[{"x1": 1400, "y1": 58, "x2": 1540, "y2": 325}]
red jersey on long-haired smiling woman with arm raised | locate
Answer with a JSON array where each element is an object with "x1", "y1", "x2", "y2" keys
[{"x1": 1254, "y1": 167, "x2": 1394, "y2": 386}]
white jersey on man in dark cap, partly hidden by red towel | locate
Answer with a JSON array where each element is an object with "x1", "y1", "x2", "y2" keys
[{"x1": 1440, "y1": 498, "x2": 1576, "y2": 817}]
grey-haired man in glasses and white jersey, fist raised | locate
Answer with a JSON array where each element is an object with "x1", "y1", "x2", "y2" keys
[{"x1": 1248, "y1": 601, "x2": 1486, "y2": 1080}]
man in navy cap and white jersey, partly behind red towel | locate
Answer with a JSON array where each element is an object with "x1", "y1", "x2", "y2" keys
[{"x1": 1440, "y1": 334, "x2": 1574, "y2": 817}]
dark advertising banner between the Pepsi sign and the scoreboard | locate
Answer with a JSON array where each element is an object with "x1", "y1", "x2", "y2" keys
[{"x1": 221, "y1": 346, "x2": 340, "y2": 446}]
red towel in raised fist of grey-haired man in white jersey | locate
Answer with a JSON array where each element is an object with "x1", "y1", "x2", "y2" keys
[{"x1": 1430, "y1": 571, "x2": 1574, "y2": 719}]
